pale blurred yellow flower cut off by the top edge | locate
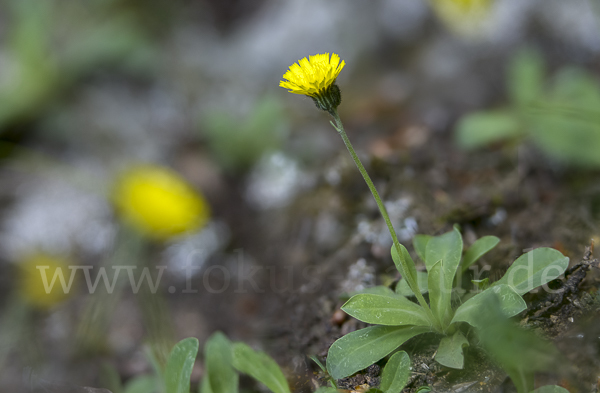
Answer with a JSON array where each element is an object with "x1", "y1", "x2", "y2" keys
[{"x1": 430, "y1": 0, "x2": 494, "y2": 36}]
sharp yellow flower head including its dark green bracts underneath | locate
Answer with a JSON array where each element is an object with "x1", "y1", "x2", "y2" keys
[{"x1": 279, "y1": 53, "x2": 346, "y2": 111}]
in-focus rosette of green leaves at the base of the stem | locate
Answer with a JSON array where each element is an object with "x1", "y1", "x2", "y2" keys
[{"x1": 327, "y1": 227, "x2": 569, "y2": 378}]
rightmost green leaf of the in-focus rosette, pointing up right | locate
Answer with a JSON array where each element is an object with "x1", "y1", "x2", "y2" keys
[{"x1": 493, "y1": 247, "x2": 569, "y2": 295}]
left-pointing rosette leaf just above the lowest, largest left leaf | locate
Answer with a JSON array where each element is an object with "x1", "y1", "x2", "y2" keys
[{"x1": 342, "y1": 294, "x2": 431, "y2": 326}]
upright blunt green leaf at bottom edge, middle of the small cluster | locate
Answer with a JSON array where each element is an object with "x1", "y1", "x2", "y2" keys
[{"x1": 204, "y1": 332, "x2": 239, "y2": 393}]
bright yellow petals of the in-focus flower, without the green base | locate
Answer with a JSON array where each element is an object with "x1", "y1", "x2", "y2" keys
[{"x1": 279, "y1": 53, "x2": 346, "y2": 97}]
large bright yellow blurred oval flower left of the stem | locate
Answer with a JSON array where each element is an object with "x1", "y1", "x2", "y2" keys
[{"x1": 113, "y1": 165, "x2": 210, "y2": 239}]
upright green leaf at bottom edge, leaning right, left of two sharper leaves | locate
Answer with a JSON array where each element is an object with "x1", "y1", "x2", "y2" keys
[{"x1": 165, "y1": 337, "x2": 199, "y2": 393}]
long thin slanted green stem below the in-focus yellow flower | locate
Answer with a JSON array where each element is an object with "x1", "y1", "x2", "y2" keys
[{"x1": 329, "y1": 109, "x2": 435, "y2": 321}]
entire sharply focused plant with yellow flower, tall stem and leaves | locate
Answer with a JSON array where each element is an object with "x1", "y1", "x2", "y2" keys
[{"x1": 280, "y1": 53, "x2": 569, "y2": 391}]
